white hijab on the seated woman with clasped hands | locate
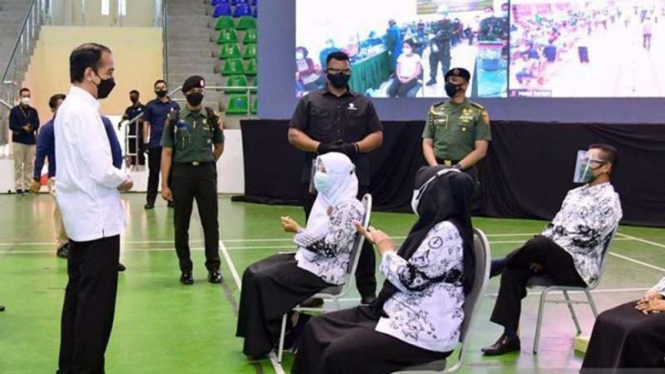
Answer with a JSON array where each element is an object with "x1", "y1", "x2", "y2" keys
[{"x1": 301, "y1": 152, "x2": 358, "y2": 257}]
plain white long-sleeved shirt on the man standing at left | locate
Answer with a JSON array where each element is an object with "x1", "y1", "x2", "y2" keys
[{"x1": 54, "y1": 86, "x2": 128, "y2": 242}]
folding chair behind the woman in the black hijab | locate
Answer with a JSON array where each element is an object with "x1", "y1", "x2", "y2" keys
[{"x1": 393, "y1": 229, "x2": 492, "y2": 374}]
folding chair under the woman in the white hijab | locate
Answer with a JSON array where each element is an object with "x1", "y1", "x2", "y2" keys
[{"x1": 277, "y1": 194, "x2": 372, "y2": 363}]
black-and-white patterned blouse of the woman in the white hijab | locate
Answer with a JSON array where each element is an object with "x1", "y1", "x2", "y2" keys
[{"x1": 293, "y1": 199, "x2": 365, "y2": 285}]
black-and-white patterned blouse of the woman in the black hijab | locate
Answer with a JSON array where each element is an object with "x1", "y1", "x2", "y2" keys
[{"x1": 376, "y1": 222, "x2": 464, "y2": 352}]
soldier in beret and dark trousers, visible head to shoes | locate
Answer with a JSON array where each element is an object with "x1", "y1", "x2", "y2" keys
[{"x1": 161, "y1": 75, "x2": 224, "y2": 285}]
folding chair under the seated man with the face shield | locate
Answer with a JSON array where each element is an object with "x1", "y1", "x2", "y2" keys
[{"x1": 527, "y1": 230, "x2": 616, "y2": 354}]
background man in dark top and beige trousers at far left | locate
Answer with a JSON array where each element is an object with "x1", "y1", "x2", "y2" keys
[{"x1": 9, "y1": 87, "x2": 39, "y2": 195}]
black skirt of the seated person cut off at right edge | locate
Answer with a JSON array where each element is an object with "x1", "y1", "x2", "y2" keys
[{"x1": 582, "y1": 301, "x2": 665, "y2": 373}]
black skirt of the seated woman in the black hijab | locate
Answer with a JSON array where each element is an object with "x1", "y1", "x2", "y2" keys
[{"x1": 291, "y1": 306, "x2": 451, "y2": 374}]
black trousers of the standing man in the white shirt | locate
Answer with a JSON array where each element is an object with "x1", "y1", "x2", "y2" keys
[{"x1": 57, "y1": 236, "x2": 120, "y2": 374}]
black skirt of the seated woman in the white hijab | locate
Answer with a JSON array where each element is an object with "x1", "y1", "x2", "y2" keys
[{"x1": 236, "y1": 254, "x2": 332, "y2": 357}]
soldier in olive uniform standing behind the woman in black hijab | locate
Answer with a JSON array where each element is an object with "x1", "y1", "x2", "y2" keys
[{"x1": 423, "y1": 68, "x2": 492, "y2": 213}]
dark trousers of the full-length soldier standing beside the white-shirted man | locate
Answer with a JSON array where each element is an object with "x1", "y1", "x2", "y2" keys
[{"x1": 171, "y1": 162, "x2": 220, "y2": 272}]
